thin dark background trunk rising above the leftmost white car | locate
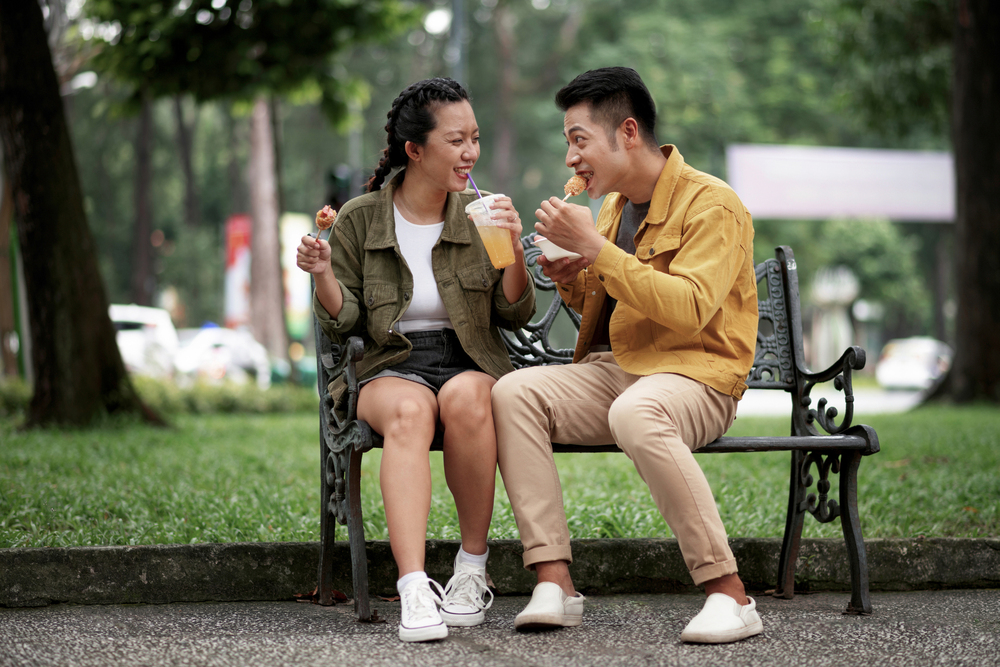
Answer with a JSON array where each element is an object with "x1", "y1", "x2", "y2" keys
[{"x1": 131, "y1": 94, "x2": 154, "y2": 306}]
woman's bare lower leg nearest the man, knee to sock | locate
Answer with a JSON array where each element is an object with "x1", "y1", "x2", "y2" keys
[{"x1": 437, "y1": 371, "x2": 497, "y2": 554}]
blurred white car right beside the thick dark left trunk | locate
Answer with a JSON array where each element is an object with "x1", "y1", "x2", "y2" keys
[{"x1": 108, "y1": 304, "x2": 178, "y2": 378}]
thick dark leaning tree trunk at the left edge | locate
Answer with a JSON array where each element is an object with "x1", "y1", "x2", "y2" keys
[{"x1": 0, "y1": 0, "x2": 157, "y2": 426}]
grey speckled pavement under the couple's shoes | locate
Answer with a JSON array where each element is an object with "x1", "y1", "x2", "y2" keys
[{"x1": 0, "y1": 590, "x2": 1000, "y2": 667}]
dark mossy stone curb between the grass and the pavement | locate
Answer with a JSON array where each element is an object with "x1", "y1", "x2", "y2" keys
[{"x1": 0, "y1": 538, "x2": 1000, "y2": 607}]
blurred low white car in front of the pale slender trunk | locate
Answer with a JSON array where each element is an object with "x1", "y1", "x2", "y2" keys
[{"x1": 174, "y1": 327, "x2": 271, "y2": 389}]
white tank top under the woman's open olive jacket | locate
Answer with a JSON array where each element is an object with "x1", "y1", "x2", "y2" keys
[{"x1": 392, "y1": 204, "x2": 455, "y2": 334}]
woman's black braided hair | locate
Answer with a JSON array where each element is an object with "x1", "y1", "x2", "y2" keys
[{"x1": 365, "y1": 77, "x2": 469, "y2": 192}]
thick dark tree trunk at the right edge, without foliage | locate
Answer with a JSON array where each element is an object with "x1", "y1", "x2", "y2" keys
[{"x1": 949, "y1": 0, "x2": 1000, "y2": 402}]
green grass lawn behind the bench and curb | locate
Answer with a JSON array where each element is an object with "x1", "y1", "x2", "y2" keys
[{"x1": 0, "y1": 406, "x2": 1000, "y2": 547}]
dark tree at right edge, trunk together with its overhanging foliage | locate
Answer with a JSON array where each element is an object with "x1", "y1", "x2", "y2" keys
[{"x1": 819, "y1": 0, "x2": 1000, "y2": 402}]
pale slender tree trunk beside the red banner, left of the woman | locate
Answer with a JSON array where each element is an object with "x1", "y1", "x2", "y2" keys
[{"x1": 250, "y1": 96, "x2": 288, "y2": 359}]
